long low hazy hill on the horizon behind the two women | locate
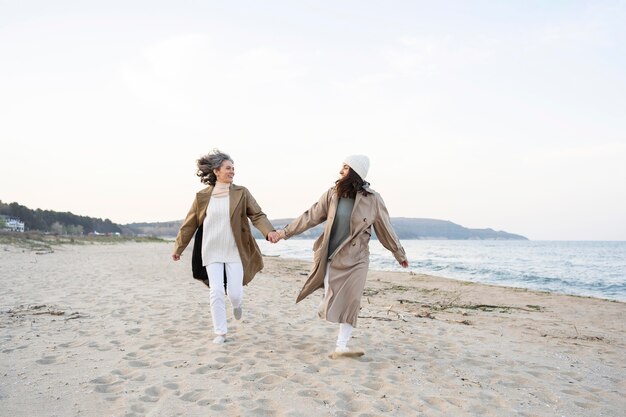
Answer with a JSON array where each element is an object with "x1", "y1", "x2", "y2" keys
[{"x1": 124, "y1": 217, "x2": 528, "y2": 240}]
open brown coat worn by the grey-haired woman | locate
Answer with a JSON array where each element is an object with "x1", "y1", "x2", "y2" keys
[{"x1": 174, "y1": 184, "x2": 275, "y2": 285}]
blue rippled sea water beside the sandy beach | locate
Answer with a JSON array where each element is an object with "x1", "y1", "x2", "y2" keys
[{"x1": 257, "y1": 239, "x2": 626, "y2": 302}]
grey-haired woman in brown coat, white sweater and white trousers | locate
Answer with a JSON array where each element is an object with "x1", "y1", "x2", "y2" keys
[{"x1": 172, "y1": 149, "x2": 278, "y2": 344}]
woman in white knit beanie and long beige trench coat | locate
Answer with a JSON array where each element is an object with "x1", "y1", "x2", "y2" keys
[{"x1": 272, "y1": 155, "x2": 409, "y2": 358}]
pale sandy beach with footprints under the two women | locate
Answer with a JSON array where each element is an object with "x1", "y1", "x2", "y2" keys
[{"x1": 0, "y1": 242, "x2": 626, "y2": 417}]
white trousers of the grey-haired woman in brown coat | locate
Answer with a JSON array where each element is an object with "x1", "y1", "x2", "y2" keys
[{"x1": 206, "y1": 262, "x2": 243, "y2": 335}]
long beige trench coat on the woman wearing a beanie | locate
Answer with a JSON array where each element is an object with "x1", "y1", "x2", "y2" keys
[{"x1": 285, "y1": 187, "x2": 407, "y2": 326}]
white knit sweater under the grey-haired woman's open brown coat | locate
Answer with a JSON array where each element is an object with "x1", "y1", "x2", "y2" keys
[{"x1": 202, "y1": 193, "x2": 241, "y2": 266}]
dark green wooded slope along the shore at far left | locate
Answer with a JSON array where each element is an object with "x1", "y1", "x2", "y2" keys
[{"x1": 0, "y1": 200, "x2": 122, "y2": 235}]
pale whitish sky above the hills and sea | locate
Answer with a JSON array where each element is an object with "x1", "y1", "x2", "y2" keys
[{"x1": 0, "y1": 0, "x2": 626, "y2": 240}]
